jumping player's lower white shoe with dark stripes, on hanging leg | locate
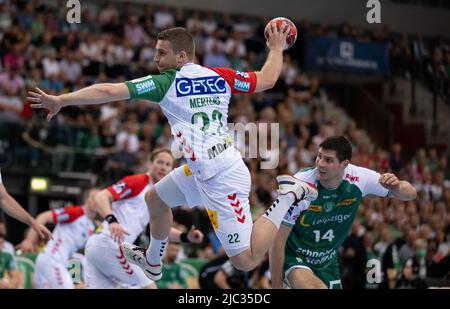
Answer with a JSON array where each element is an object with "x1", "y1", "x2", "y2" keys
[{"x1": 120, "y1": 242, "x2": 162, "y2": 281}]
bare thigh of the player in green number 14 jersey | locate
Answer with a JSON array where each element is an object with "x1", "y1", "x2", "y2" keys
[{"x1": 285, "y1": 266, "x2": 327, "y2": 289}]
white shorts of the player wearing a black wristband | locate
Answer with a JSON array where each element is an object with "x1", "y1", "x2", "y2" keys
[{"x1": 85, "y1": 234, "x2": 153, "y2": 289}]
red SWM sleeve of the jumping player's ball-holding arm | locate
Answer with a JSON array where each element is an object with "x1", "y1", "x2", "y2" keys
[{"x1": 209, "y1": 68, "x2": 256, "y2": 93}]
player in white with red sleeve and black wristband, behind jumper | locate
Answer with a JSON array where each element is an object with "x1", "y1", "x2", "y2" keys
[{"x1": 85, "y1": 148, "x2": 203, "y2": 289}]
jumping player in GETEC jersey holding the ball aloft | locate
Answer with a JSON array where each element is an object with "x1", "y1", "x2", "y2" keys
[{"x1": 28, "y1": 23, "x2": 317, "y2": 280}]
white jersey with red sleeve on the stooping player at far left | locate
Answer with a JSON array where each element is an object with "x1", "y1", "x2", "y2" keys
[{"x1": 43, "y1": 206, "x2": 94, "y2": 264}]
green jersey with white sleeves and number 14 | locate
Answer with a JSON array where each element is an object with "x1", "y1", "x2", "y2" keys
[{"x1": 283, "y1": 164, "x2": 389, "y2": 266}]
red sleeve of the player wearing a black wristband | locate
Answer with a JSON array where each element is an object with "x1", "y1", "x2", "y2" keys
[{"x1": 107, "y1": 174, "x2": 150, "y2": 201}]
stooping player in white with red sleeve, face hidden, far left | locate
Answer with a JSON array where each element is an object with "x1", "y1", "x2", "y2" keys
[{"x1": 18, "y1": 189, "x2": 98, "y2": 289}]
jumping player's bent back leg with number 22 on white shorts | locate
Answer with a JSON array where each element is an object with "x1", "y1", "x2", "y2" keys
[{"x1": 204, "y1": 160, "x2": 317, "y2": 271}]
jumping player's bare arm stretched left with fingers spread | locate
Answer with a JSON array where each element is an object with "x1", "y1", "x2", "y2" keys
[{"x1": 27, "y1": 83, "x2": 130, "y2": 120}]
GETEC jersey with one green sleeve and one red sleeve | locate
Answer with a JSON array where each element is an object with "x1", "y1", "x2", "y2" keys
[{"x1": 125, "y1": 63, "x2": 256, "y2": 179}]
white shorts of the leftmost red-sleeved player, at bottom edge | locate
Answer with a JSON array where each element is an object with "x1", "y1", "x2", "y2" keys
[{"x1": 34, "y1": 254, "x2": 74, "y2": 289}]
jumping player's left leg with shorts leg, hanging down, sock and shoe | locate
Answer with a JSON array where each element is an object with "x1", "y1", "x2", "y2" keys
[{"x1": 122, "y1": 165, "x2": 201, "y2": 280}]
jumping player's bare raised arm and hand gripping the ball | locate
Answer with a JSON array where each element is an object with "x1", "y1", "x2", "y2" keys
[{"x1": 255, "y1": 22, "x2": 289, "y2": 92}]
